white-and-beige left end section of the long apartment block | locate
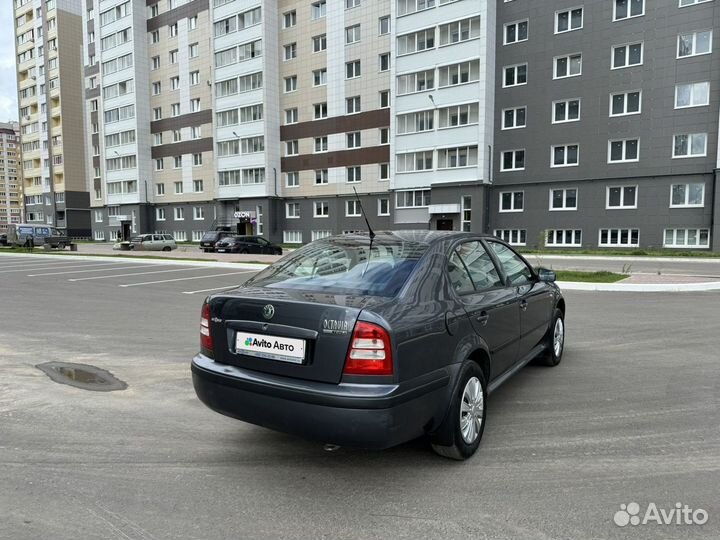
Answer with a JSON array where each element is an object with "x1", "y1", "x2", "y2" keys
[{"x1": 84, "y1": 0, "x2": 215, "y2": 241}]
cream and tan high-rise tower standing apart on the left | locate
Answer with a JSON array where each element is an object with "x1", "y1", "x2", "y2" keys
[{"x1": 14, "y1": 0, "x2": 90, "y2": 236}]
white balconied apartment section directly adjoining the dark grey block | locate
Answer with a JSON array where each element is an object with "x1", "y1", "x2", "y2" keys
[{"x1": 390, "y1": 0, "x2": 496, "y2": 231}]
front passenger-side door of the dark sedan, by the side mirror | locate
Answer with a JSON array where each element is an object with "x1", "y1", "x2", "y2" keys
[{"x1": 487, "y1": 240, "x2": 554, "y2": 357}]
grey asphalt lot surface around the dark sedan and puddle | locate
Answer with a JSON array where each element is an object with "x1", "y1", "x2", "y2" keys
[{"x1": 0, "y1": 256, "x2": 720, "y2": 540}]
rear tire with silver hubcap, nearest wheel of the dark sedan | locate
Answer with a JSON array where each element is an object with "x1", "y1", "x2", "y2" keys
[{"x1": 432, "y1": 360, "x2": 487, "y2": 461}]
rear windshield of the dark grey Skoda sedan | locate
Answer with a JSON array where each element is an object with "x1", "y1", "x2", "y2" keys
[{"x1": 247, "y1": 237, "x2": 427, "y2": 296}]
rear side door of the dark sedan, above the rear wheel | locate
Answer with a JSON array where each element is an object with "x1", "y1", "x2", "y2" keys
[{"x1": 449, "y1": 240, "x2": 520, "y2": 378}]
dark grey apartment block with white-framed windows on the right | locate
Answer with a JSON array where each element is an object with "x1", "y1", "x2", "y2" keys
[{"x1": 490, "y1": 0, "x2": 720, "y2": 250}]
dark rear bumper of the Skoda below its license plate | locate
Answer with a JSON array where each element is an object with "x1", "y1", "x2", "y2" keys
[{"x1": 191, "y1": 355, "x2": 450, "y2": 449}]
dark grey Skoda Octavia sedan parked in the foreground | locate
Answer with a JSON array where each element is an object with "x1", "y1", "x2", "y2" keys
[{"x1": 192, "y1": 231, "x2": 565, "y2": 459}]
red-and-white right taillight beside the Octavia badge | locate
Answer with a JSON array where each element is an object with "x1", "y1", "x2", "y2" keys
[{"x1": 344, "y1": 321, "x2": 393, "y2": 375}]
